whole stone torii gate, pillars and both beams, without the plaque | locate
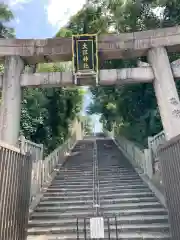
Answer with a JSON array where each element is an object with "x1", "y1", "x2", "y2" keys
[{"x1": 0, "y1": 27, "x2": 180, "y2": 145}]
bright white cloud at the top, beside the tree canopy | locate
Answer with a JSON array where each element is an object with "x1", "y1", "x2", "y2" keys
[{"x1": 45, "y1": 0, "x2": 86, "y2": 28}]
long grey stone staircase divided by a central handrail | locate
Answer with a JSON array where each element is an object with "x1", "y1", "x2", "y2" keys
[{"x1": 28, "y1": 139, "x2": 170, "y2": 240}]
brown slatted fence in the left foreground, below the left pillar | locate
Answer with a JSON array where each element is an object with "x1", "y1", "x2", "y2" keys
[{"x1": 0, "y1": 142, "x2": 32, "y2": 240}]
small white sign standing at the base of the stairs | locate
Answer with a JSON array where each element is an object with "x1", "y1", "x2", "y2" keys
[{"x1": 90, "y1": 217, "x2": 104, "y2": 239}]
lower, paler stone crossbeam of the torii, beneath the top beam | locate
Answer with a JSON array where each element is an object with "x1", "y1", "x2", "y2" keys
[{"x1": 0, "y1": 63, "x2": 180, "y2": 88}]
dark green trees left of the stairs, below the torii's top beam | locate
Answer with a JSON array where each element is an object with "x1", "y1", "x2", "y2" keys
[{"x1": 21, "y1": 63, "x2": 84, "y2": 153}]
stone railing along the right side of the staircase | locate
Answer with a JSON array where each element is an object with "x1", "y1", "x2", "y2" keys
[{"x1": 106, "y1": 129, "x2": 165, "y2": 204}]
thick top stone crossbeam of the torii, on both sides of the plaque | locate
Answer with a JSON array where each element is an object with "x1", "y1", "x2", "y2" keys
[{"x1": 0, "y1": 26, "x2": 180, "y2": 64}]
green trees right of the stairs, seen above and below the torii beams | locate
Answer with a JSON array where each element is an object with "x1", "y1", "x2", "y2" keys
[{"x1": 60, "y1": 0, "x2": 180, "y2": 145}]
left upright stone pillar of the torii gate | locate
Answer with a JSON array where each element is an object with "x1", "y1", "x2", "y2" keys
[{"x1": 0, "y1": 56, "x2": 24, "y2": 146}]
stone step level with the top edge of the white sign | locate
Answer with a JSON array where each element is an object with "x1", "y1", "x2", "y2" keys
[{"x1": 28, "y1": 215, "x2": 168, "y2": 227}]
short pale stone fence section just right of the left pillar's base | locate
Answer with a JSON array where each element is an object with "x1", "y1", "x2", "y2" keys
[{"x1": 18, "y1": 136, "x2": 43, "y2": 162}]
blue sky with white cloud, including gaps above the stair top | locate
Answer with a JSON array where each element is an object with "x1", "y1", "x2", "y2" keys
[{"x1": 4, "y1": 0, "x2": 101, "y2": 132}]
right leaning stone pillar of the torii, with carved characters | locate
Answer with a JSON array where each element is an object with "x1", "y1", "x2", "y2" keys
[{"x1": 148, "y1": 47, "x2": 180, "y2": 140}]
